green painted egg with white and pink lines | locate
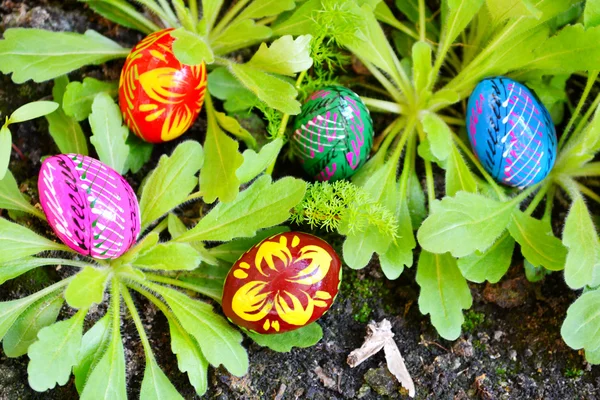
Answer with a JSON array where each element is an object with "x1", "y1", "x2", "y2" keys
[{"x1": 291, "y1": 86, "x2": 373, "y2": 181}]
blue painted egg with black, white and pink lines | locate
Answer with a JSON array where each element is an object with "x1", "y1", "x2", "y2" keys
[{"x1": 467, "y1": 77, "x2": 557, "y2": 189}]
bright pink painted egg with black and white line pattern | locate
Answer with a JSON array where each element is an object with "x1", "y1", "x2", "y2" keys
[{"x1": 38, "y1": 154, "x2": 140, "y2": 259}]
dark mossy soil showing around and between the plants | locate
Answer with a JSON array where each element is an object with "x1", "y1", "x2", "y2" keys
[{"x1": 0, "y1": 0, "x2": 600, "y2": 400}]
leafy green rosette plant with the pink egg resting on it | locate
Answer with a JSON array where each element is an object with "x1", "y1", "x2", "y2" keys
[{"x1": 0, "y1": 141, "x2": 322, "y2": 399}]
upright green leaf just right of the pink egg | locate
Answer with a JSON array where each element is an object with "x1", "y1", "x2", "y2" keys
[{"x1": 140, "y1": 141, "x2": 204, "y2": 230}]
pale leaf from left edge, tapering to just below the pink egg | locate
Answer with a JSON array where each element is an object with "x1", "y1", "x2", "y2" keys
[{"x1": 0, "y1": 218, "x2": 65, "y2": 264}]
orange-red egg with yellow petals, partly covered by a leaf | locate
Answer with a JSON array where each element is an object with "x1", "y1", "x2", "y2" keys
[{"x1": 119, "y1": 29, "x2": 206, "y2": 143}]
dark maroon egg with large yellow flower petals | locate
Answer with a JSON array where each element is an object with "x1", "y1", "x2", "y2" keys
[{"x1": 222, "y1": 232, "x2": 342, "y2": 334}]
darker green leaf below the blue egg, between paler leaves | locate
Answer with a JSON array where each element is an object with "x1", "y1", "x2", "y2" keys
[{"x1": 508, "y1": 210, "x2": 567, "y2": 271}]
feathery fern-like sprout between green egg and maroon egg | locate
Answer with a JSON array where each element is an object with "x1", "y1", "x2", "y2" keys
[{"x1": 290, "y1": 181, "x2": 398, "y2": 238}]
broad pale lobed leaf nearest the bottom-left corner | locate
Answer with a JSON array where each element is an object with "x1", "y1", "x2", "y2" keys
[{"x1": 27, "y1": 310, "x2": 87, "y2": 392}]
